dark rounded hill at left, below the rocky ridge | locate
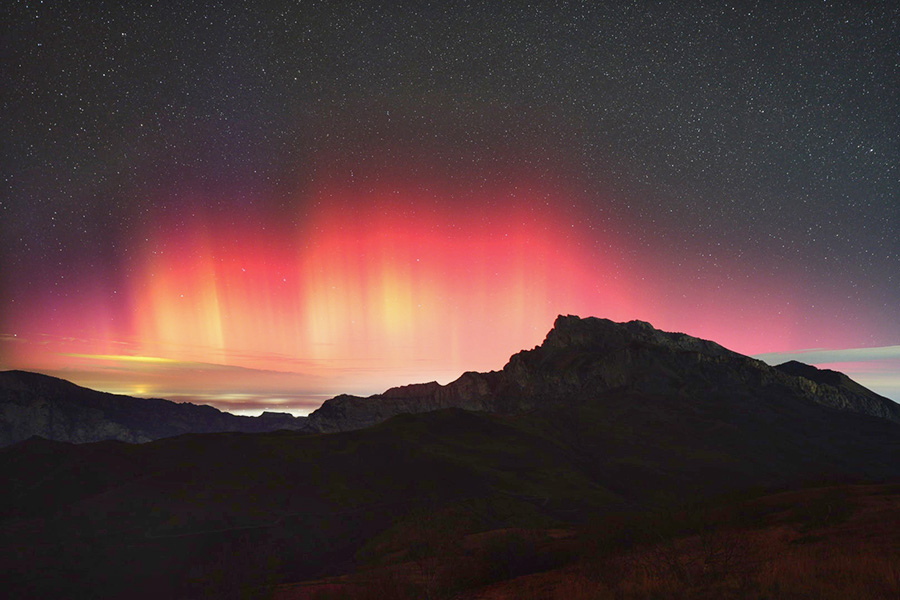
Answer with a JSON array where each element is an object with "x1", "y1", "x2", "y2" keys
[{"x1": 0, "y1": 410, "x2": 616, "y2": 597}]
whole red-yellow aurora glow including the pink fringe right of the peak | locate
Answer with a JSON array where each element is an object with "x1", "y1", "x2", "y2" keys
[{"x1": 6, "y1": 183, "x2": 892, "y2": 408}]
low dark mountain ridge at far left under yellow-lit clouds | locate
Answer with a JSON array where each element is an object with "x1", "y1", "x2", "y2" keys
[{"x1": 0, "y1": 371, "x2": 304, "y2": 446}]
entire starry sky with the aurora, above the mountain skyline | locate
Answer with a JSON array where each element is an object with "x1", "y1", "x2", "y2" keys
[{"x1": 0, "y1": 0, "x2": 900, "y2": 414}]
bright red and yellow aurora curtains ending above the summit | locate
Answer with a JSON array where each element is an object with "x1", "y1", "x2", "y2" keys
[{"x1": 37, "y1": 183, "x2": 630, "y2": 391}]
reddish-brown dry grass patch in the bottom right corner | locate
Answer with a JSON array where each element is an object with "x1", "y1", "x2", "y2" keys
[{"x1": 466, "y1": 486, "x2": 900, "y2": 600}]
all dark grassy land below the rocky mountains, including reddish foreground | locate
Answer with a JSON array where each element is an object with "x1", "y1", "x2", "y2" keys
[{"x1": 7, "y1": 393, "x2": 900, "y2": 600}]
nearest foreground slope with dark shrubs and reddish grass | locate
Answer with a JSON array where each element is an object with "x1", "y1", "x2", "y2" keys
[{"x1": 282, "y1": 485, "x2": 900, "y2": 600}]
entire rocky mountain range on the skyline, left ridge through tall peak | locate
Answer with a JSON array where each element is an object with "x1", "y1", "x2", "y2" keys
[{"x1": 0, "y1": 316, "x2": 900, "y2": 446}]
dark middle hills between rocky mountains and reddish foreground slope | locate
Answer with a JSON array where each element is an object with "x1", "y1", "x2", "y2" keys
[{"x1": 0, "y1": 395, "x2": 900, "y2": 598}]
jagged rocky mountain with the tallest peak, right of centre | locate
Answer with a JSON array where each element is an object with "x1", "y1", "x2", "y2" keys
[{"x1": 306, "y1": 316, "x2": 900, "y2": 432}]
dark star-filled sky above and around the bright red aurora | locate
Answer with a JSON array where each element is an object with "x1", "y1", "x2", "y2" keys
[{"x1": 0, "y1": 1, "x2": 900, "y2": 408}]
